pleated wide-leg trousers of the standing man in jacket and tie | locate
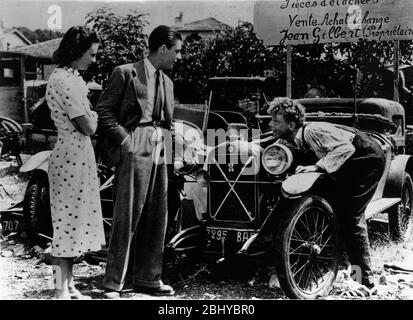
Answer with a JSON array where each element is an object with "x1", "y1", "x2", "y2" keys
[{"x1": 104, "y1": 126, "x2": 168, "y2": 291}]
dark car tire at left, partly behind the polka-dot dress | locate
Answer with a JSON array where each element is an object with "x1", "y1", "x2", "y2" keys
[{"x1": 23, "y1": 171, "x2": 53, "y2": 248}]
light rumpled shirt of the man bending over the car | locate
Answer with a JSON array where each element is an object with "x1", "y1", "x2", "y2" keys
[{"x1": 295, "y1": 122, "x2": 355, "y2": 173}]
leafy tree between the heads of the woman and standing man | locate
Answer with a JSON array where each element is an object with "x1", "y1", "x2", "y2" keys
[{"x1": 84, "y1": 7, "x2": 148, "y2": 86}]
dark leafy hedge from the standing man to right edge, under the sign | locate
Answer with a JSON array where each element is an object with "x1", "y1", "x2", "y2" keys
[{"x1": 172, "y1": 22, "x2": 413, "y2": 103}]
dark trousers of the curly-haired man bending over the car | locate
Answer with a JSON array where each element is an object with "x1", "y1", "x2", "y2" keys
[{"x1": 332, "y1": 132, "x2": 385, "y2": 279}]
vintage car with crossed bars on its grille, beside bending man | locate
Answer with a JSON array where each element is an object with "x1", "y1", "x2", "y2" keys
[{"x1": 167, "y1": 78, "x2": 413, "y2": 299}]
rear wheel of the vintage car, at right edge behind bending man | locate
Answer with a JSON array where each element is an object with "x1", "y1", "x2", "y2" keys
[{"x1": 389, "y1": 172, "x2": 413, "y2": 242}]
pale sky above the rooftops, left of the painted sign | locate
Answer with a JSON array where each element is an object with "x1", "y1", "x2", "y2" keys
[{"x1": 0, "y1": 0, "x2": 254, "y2": 32}]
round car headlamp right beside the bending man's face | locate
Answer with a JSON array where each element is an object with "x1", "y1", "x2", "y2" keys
[{"x1": 262, "y1": 143, "x2": 293, "y2": 176}]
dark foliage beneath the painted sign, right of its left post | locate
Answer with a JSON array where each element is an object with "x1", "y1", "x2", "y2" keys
[{"x1": 293, "y1": 40, "x2": 412, "y2": 98}]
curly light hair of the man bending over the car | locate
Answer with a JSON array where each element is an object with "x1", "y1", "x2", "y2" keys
[{"x1": 268, "y1": 98, "x2": 305, "y2": 128}]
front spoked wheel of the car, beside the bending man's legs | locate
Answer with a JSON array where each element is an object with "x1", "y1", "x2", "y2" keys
[{"x1": 275, "y1": 195, "x2": 340, "y2": 299}]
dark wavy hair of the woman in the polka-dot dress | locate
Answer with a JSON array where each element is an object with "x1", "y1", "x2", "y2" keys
[{"x1": 53, "y1": 26, "x2": 100, "y2": 67}]
